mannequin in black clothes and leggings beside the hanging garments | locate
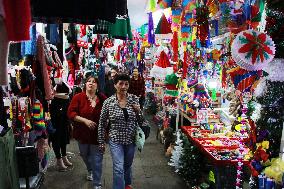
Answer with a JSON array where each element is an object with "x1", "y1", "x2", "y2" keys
[{"x1": 49, "y1": 83, "x2": 72, "y2": 171}]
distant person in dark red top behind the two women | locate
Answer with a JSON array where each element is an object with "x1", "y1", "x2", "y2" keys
[{"x1": 129, "y1": 68, "x2": 145, "y2": 109}]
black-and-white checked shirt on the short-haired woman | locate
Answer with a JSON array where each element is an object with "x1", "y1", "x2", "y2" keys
[{"x1": 98, "y1": 94, "x2": 143, "y2": 145}]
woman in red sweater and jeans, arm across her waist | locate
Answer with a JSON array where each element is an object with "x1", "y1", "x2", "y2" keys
[{"x1": 68, "y1": 76, "x2": 106, "y2": 189}]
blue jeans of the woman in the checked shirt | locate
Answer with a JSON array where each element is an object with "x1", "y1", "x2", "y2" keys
[{"x1": 109, "y1": 140, "x2": 136, "y2": 189}]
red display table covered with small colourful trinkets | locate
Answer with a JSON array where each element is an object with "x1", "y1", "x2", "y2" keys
[{"x1": 181, "y1": 126, "x2": 249, "y2": 189}]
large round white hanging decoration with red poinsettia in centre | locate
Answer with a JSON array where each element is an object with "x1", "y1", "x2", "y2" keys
[{"x1": 232, "y1": 30, "x2": 275, "y2": 70}]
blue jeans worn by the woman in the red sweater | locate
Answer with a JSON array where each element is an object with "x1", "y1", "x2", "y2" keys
[{"x1": 78, "y1": 142, "x2": 103, "y2": 186}]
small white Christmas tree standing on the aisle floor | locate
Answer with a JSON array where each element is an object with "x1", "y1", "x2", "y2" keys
[{"x1": 168, "y1": 130, "x2": 183, "y2": 172}]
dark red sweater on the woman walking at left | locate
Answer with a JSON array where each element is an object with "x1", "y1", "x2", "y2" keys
[{"x1": 67, "y1": 92, "x2": 106, "y2": 144}]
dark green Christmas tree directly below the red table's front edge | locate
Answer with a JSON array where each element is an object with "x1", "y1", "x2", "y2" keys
[{"x1": 179, "y1": 134, "x2": 209, "y2": 186}]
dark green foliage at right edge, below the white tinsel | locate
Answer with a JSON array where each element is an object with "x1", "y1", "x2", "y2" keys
[{"x1": 256, "y1": 81, "x2": 284, "y2": 157}]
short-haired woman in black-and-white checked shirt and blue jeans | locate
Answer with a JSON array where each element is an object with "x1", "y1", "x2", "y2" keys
[{"x1": 98, "y1": 74, "x2": 143, "y2": 189}]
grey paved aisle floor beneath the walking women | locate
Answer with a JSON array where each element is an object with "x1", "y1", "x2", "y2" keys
[{"x1": 41, "y1": 116, "x2": 186, "y2": 189}]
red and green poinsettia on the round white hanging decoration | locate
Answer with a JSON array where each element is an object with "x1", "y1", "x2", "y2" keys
[{"x1": 238, "y1": 31, "x2": 273, "y2": 64}]
